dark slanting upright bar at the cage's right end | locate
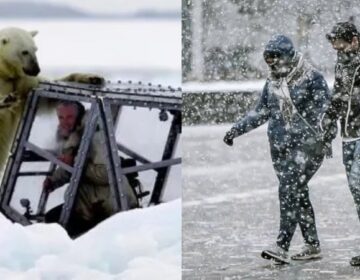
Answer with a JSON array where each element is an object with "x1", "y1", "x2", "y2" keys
[{"x1": 149, "y1": 112, "x2": 181, "y2": 204}]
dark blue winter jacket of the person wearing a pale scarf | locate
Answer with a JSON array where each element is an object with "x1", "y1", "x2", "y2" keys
[{"x1": 233, "y1": 54, "x2": 335, "y2": 153}]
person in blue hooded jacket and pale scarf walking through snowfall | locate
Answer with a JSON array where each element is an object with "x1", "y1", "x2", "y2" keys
[{"x1": 224, "y1": 35, "x2": 336, "y2": 264}]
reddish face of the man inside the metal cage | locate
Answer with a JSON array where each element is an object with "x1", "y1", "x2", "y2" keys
[{"x1": 56, "y1": 104, "x2": 78, "y2": 137}]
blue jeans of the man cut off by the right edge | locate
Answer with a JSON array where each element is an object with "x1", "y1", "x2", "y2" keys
[{"x1": 343, "y1": 140, "x2": 360, "y2": 218}]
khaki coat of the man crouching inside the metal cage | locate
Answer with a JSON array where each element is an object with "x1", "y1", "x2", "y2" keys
[{"x1": 50, "y1": 126, "x2": 137, "y2": 221}]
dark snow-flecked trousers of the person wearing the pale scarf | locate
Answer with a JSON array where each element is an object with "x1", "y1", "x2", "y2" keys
[{"x1": 271, "y1": 145, "x2": 324, "y2": 250}]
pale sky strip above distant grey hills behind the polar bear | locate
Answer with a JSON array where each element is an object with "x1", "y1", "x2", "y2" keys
[{"x1": 0, "y1": 0, "x2": 181, "y2": 14}]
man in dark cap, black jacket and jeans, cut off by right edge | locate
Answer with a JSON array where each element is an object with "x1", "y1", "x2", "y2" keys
[{"x1": 322, "y1": 22, "x2": 360, "y2": 266}]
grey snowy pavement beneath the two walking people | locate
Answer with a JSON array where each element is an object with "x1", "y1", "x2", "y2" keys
[{"x1": 182, "y1": 125, "x2": 360, "y2": 280}]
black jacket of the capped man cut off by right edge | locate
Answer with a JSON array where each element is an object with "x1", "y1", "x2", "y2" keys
[{"x1": 325, "y1": 50, "x2": 360, "y2": 138}]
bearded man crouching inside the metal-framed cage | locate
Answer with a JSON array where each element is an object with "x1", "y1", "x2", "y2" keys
[{"x1": 43, "y1": 101, "x2": 138, "y2": 236}]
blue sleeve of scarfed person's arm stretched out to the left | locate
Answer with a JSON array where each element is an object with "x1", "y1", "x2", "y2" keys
[{"x1": 233, "y1": 82, "x2": 270, "y2": 137}]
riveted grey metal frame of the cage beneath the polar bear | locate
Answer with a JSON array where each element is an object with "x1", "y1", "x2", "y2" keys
[{"x1": 0, "y1": 82, "x2": 182, "y2": 227}]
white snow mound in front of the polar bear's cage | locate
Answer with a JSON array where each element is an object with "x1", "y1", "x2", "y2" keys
[{"x1": 0, "y1": 199, "x2": 181, "y2": 280}]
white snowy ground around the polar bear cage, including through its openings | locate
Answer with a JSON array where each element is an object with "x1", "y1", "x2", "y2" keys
[{"x1": 0, "y1": 19, "x2": 181, "y2": 280}]
